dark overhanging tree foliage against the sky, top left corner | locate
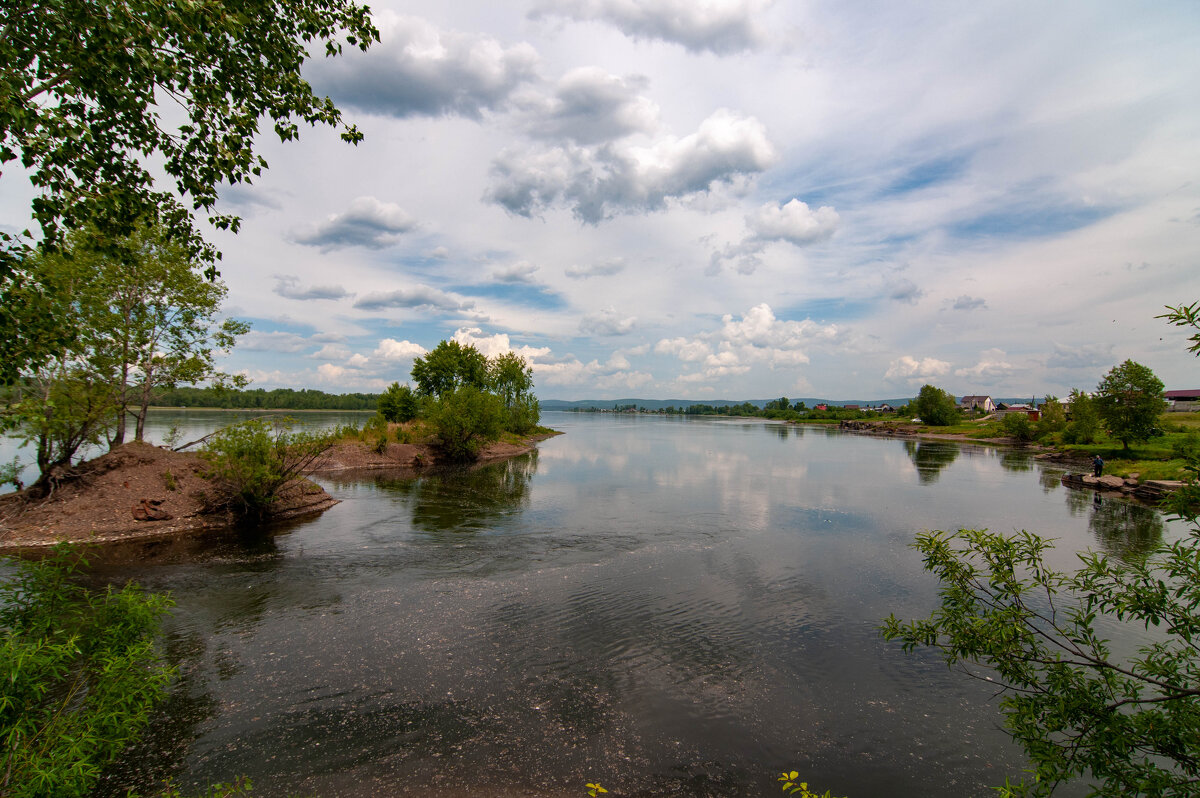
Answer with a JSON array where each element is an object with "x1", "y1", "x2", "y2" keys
[{"x1": 0, "y1": 0, "x2": 379, "y2": 268}]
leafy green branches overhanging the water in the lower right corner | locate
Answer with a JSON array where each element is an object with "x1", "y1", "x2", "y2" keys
[{"x1": 882, "y1": 520, "x2": 1200, "y2": 796}]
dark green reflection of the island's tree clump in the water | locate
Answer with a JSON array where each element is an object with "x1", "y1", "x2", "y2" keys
[{"x1": 377, "y1": 450, "x2": 538, "y2": 532}]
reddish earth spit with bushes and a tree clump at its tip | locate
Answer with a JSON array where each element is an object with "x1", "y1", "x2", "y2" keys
[{"x1": 0, "y1": 341, "x2": 558, "y2": 552}]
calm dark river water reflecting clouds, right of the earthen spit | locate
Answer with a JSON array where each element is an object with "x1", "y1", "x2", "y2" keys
[{"x1": 88, "y1": 413, "x2": 1183, "y2": 798}]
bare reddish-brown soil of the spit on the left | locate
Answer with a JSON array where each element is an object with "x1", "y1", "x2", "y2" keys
[{"x1": 0, "y1": 436, "x2": 546, "y2": 551}]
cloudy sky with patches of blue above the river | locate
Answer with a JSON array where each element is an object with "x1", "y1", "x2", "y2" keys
[{"x1": 5, "y1": 0, "x2": 1200, "y2": 401}]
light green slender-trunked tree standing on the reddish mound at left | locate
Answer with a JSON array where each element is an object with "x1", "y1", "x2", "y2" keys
[{"x1": 4, "y1": 222, "x2": 248, "y2": 490}]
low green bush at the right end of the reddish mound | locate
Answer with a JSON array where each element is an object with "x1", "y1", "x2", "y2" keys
[{"x1": 200, "y1": 419, "x2": 332, "y2": 517}]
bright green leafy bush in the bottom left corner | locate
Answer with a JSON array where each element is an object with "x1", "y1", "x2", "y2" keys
[{"x1": 0, "y1": 546, "x2": 174, "y2": 798}]
